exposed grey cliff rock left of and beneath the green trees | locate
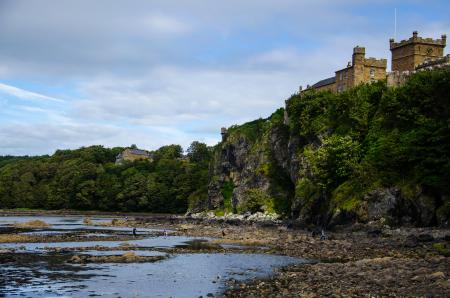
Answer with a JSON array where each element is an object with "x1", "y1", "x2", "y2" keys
[{"x1": 192, "y1": 113, "x2": 446, "y2": 226}]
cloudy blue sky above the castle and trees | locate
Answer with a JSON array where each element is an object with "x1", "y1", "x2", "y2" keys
[{"x1": 0, "y1": 0, "x2": 450, "y2": 155}]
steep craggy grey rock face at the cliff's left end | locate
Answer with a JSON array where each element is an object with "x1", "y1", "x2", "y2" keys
[{"x1": 202, "y1": 111, "x2": 294, "y2": 214}]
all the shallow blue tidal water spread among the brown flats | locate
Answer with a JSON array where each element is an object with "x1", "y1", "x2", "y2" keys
[{"x1": 0, "y1": 217, "x2": 304, "y2": 297}]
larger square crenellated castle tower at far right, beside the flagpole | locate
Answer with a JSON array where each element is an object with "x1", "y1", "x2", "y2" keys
[{"x1": 389, "y1": 31, "x2": 447, "y2": 71}]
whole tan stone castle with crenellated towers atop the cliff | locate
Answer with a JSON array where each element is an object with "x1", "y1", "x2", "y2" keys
[{"x1": 300, "y1": 31, "x2": 450, "y2": 93}]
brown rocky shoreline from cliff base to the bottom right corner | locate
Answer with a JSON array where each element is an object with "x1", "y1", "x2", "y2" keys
[{"x1": 0, "y1": 210, "x2": 450, "y2": 297}]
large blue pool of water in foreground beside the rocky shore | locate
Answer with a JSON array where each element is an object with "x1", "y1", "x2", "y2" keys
[{"x1": 0, "y1": 254, "x2": 298, "y2": 297}]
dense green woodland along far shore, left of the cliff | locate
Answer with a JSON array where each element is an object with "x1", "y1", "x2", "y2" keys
[{"x1": 0, "y1": 142, "x2": 211, "y2": 212}]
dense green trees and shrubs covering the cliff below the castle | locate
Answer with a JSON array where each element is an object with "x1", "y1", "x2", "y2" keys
[{"x1": 287, "y1": 70, "x2": 450, "y2": 220}]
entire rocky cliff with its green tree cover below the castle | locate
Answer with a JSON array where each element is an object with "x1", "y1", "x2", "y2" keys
[{"x1": 192, "y1": 73, "x2": 450, "y2": 226}]
